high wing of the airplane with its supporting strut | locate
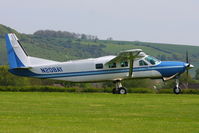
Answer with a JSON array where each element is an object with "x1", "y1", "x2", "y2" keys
[{"x1": 105, "y1": 49, "x2": 145, "y2": 77}]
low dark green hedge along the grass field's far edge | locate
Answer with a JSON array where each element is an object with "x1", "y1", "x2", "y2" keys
[{"x1": 0, "y1": 86, "x2": 199, "y2": 94}]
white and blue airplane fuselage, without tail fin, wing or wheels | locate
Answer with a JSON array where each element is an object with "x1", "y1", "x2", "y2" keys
[{"x1": 10, "y1": 55, "x2": 187, "y2": 82}]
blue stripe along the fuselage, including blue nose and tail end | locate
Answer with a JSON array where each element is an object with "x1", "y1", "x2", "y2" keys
[{"x1": 9, "y1": 61, "x2": 185, "y2": 78}]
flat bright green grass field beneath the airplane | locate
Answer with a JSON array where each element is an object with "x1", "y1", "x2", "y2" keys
[{"x1": 0, "y1": 92, "x2": 199, "y2": 133}]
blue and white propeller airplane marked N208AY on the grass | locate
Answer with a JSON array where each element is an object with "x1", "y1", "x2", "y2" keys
[{"x1": 5, "y1": 33, "x2": 194, "y2": 94}]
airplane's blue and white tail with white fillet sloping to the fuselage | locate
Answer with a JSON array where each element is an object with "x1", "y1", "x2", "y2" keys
[{"x1": 6, "y1": 33, "x2": 59, "y2": 69}]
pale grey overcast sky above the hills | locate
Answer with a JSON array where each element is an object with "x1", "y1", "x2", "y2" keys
[{"x1": 0, "y1": 0, "x2": 199, "y2": 46}]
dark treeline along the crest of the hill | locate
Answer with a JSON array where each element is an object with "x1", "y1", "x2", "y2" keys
[{"x1": 33, "y1": 30, "x2": 98, "y2": 40}]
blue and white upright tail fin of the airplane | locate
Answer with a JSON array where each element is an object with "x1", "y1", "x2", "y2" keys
[{"x1": 6, "y1": 33, "x2": 29, "y2": 69}]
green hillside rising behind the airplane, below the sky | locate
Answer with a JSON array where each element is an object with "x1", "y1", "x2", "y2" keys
[{"x1": 0, "y1": 25, "x2": 199, "y2": 74}]
